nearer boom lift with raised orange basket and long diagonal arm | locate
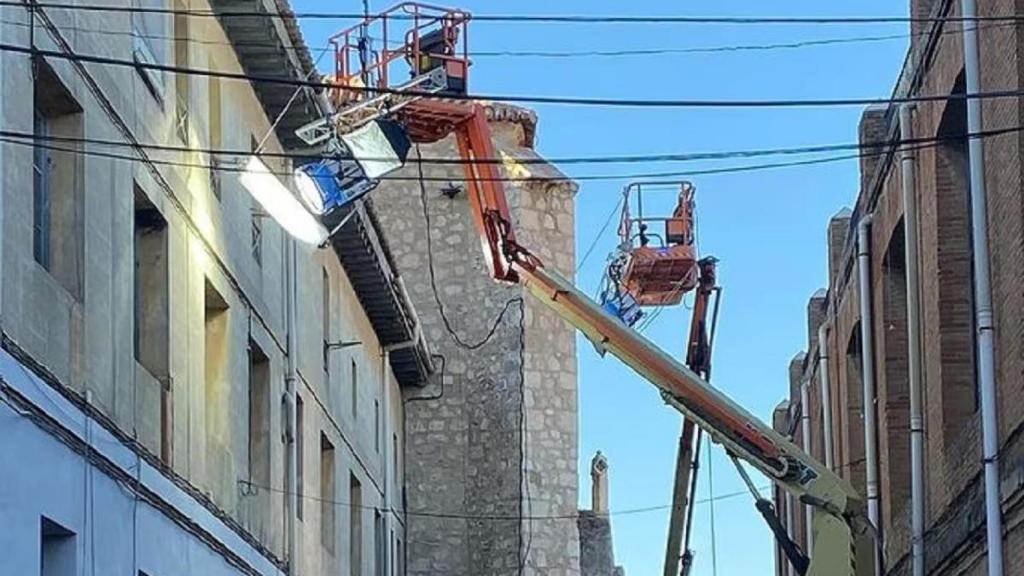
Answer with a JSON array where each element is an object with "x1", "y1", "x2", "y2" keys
[{"x1": 297, "y1": 2, "x2": 874, "y2": 576}]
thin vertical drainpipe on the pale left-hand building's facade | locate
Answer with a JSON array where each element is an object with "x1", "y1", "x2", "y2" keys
[{"x1": 284, "y1": 239, "x2": 299, "y2": 576}]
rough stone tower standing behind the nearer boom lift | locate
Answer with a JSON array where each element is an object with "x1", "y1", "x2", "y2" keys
[{"x1": 374, "y1": 104, "x2": 580, "y2": 575}]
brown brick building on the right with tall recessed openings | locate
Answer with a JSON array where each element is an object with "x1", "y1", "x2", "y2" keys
[{"x1": 775, "y1": 0, "x2": 1024, "y2": 575}]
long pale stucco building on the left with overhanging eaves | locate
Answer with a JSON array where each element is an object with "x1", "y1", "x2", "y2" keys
[{"x1": 0, "y1": 0, "x2": 428, "y2": 576}]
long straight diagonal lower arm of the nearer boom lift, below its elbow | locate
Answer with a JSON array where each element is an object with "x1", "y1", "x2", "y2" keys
[{"x1": 516, "y1": 264, "x2": 874, "y2": 576}]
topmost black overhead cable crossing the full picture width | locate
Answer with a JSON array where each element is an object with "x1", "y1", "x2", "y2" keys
[{"x1": 0, "y1": 0, "x2": 1024, "y2": 25}]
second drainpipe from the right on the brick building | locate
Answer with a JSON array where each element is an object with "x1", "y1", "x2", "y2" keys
[{"x1": 899, "y1": 105, "x2": 925, "y2": 576}]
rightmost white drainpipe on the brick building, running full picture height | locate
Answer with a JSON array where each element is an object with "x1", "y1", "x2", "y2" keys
[{"x1": 961, "y1": 0, "x2": 1002, "y2": 576}]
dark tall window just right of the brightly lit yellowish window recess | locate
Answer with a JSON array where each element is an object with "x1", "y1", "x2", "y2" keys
[{"x1": 249, "y1": 340, "x2": 270, "y2": 491}]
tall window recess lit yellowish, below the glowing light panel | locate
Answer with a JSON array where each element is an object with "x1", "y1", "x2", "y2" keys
[{"x1": 203, "y1": 280, "x2": 228, "y2": 462}]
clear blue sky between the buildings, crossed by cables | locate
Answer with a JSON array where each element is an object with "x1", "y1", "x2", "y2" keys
[{"x1": 293, "y1": 0, "x2": 907, "y2": 576}]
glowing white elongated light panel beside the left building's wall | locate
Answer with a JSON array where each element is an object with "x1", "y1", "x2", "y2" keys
[{"x1": 239, "y1": 156, "x2": 328, "y2": 246}]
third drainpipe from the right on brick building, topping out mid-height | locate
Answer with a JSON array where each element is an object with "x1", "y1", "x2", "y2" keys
[{"x1": 857, "y1": 214, "x2": 883, "y2": 576}]
